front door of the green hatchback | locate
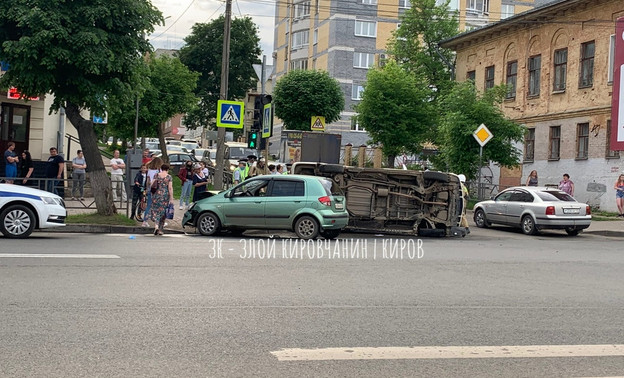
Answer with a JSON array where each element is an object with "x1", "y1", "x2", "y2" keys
[{"x1": 222, "y1": 178, "x2": 270, "y2": 228}]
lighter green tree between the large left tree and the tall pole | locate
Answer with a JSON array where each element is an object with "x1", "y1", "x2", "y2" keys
[{"x1": 109, "y1": 55, "x2": 199, "y2": 160}]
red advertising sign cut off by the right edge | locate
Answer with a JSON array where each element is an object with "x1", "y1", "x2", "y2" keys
[{"x1": 609, "y1": 17, "x2": 624, "y2": 151}]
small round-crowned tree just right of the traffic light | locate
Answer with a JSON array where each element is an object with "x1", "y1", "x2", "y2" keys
[{"x1": 273, "y1": 70, "x2": 344, "y2": 130}]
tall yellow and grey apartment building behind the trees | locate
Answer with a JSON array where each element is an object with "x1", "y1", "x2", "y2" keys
[{"x1": 273, "y1": 0, "x2": 533, "y2": 151}]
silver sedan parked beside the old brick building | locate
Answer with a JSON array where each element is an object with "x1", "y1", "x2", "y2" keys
[{"x1": 474, "y1": 186, "x2": 591, "y2": 236}]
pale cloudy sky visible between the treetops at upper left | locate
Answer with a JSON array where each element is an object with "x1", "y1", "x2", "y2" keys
[{"x1": 149, "y1": 0, "x2": 276, "y2": 64}]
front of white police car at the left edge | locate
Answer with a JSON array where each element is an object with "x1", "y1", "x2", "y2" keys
[{"x1": 0, "y1": 184, "x2": 67, "y2": 238}]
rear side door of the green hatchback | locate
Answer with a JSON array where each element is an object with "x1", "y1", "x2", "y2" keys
[{"x1": 264, "y1": 178, "x2": 306, "y2": 229}]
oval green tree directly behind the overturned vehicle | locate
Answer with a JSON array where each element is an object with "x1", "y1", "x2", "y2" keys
[{"x1": 356, "y1": 61, "x2": 432, "y2": 167}]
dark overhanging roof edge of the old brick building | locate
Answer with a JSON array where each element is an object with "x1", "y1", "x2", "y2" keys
[{"x1": 439, "y1": 0, "x2": 596, "y2": 49}]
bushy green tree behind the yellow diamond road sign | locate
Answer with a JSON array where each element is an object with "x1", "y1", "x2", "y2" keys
[{"x1": 433, "y1": 80, "x2": 525, "y2": 179}]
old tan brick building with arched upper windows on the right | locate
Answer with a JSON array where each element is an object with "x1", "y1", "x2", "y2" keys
[{"x1": 442, "y1": 0, "x2": 624, "y2": 211}]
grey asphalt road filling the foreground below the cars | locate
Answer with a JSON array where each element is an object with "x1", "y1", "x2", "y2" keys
[{"x1": 0, "y1": 229, "x2": 624, "y2": 377}]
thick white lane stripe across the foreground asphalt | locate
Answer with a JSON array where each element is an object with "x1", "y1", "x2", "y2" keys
[{"x1": 271, "y1": 344, "x2": 624, "y2": 361}]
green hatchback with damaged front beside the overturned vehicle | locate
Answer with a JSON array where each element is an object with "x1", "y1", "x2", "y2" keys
[{"x1": 182, "y1": 175, "x2": 349, "y2": 239}]
